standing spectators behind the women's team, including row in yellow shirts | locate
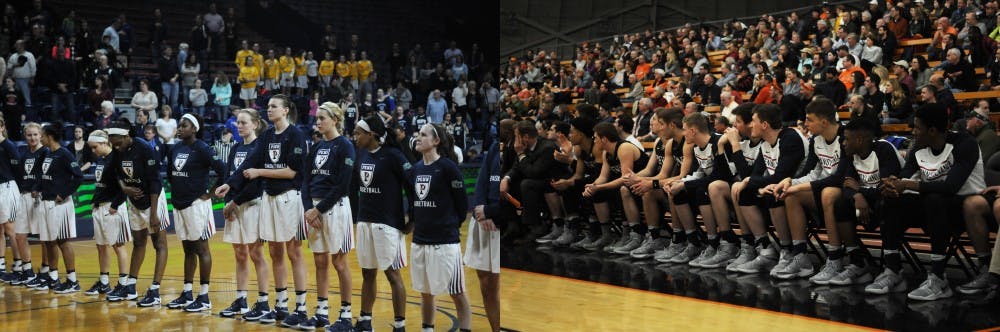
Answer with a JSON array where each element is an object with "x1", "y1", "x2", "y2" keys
[{"x1": 0, "y1": 0, "x2": 499, "y2": 166}]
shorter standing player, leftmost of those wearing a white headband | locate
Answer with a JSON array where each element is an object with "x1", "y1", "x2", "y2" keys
[{"x1": 85, "y1": 130, "x2": 132, "y2": 295}]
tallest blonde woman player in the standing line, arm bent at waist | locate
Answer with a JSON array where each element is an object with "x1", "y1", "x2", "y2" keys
[{"x1": 215, "y1": 94, "x2": 306, "y2": 324}]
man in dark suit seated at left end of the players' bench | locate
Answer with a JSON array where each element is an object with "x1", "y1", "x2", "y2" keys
[{"x1": 500, "y1": 121, "x2": 565, "y2": 241}]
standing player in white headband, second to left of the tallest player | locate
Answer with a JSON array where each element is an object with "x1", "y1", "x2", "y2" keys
[{"x1": 167, "y1": 113, "x2": 225, "y2": 312}]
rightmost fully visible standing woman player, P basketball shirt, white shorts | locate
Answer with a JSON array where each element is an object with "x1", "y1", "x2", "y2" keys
[{"x1": 410, "y1": 124, "x2": 470, "y2": 331}]
